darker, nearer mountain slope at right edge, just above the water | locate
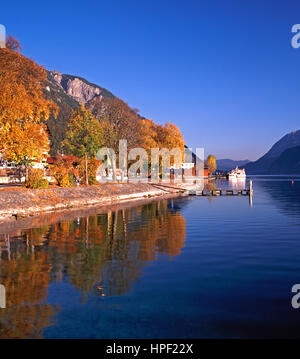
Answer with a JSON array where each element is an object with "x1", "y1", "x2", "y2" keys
[{"x1": 269, "y1": 146, "x2": 300, "y2": 174}]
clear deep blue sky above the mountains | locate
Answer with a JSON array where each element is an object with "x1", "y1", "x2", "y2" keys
[{"x1": 0, "y1": 0, "x2": 300, "y2": 160}]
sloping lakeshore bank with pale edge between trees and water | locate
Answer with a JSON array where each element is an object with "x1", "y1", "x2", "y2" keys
[{"x1": 0, "y1": 183, "x2": 182, "y2": 222}]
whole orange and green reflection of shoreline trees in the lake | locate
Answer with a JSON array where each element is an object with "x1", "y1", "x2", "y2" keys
[{"x1": 0, "y1": 200, "x2": 186, "y2": 338}]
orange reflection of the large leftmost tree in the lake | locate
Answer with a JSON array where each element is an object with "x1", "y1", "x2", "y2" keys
[{"x1": 0, "y1": 235, "x2": 58, "y2": 338}]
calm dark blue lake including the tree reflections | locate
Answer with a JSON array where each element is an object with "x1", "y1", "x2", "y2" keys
[{"x1": 0, "y1": 176, "x2": 300, "y2": 338}]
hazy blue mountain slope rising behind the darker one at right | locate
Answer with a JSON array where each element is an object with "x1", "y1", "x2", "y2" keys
[{"x1": 245, "y1": 130, "x2": 300, "y2": 174}]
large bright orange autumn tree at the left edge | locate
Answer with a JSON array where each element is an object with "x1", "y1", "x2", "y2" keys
[{"x1": 0, "y1": 44, "x2": 57, "y2": 177}]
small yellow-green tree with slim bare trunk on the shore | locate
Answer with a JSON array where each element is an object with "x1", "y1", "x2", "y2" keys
[{"x1": 62, "y1": 105, "x2": 103, "y2": 185}]
